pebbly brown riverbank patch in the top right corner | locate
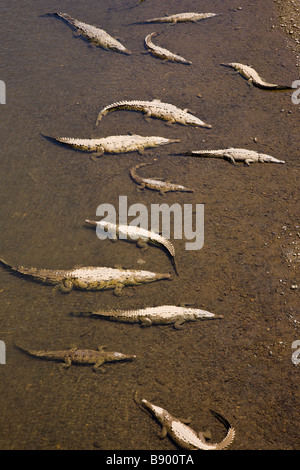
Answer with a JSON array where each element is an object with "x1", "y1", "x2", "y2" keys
[{"x1": 274, "y1": 0, "x2": 300, "y2": 67}]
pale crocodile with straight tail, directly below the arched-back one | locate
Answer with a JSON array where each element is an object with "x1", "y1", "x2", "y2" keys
[{"x1": 42, "y1": 134, "x2": 180, "y2": 158}]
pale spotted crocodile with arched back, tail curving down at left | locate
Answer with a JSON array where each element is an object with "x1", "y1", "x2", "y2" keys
[{"x1": 96, "y1": 99, "x2": 212, "y2": 129}]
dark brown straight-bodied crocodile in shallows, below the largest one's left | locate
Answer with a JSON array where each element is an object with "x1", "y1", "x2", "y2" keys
[{"x1": 16, "y1": 345, "x2": 136, "y2": 372}]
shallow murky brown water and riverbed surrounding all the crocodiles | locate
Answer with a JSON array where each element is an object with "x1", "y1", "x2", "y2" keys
[{"x1": 0, "y1": 0, "x2": 300, "y2": 450}]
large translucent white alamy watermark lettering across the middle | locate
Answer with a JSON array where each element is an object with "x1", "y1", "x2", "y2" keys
[{"x1": 96, "y1": 196, "x2": 204, "y2": 250}]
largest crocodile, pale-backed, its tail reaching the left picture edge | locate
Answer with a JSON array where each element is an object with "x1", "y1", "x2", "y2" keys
[{"x1": 0, "y1": 259, "x2": 171, "y2": 295}]
